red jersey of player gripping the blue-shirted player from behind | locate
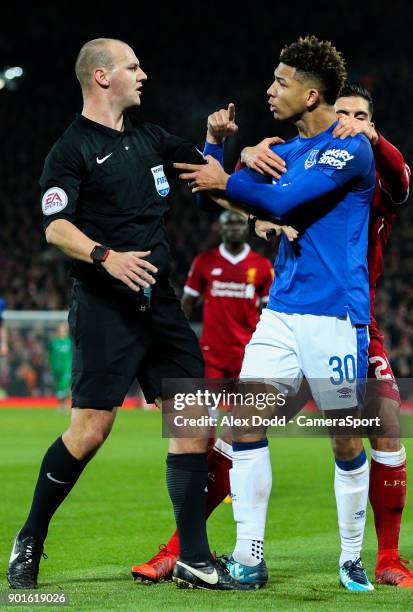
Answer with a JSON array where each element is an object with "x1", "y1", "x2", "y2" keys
[{"x1": 367, "y1": 134, "x2": 410, "y2": 332}]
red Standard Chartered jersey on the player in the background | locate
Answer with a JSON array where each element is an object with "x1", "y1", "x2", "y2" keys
[{"x1": 184, "y1": 244, "x2": 274, "y2": 354}]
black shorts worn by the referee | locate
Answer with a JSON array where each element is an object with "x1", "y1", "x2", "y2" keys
[{"x1": 69, "y1": 282, "x2": 204, "y2": 409}]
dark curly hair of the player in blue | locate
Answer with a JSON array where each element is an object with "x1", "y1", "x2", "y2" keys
[{"x1": 280, "y1": 35, "x2": 347, "y2": 104}]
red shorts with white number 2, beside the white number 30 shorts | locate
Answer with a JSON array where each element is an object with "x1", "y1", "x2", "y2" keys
[{"x1": 368, "y1": 327, "x2": 400, "y2": 403}]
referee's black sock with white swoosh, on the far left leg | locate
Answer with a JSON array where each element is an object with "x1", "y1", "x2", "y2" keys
[{"x1": 20, "y1": 437, "x2": 88, "y2": 542}]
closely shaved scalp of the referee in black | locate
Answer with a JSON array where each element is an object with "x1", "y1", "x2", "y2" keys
[{"x1": 75, "y1": 38, "x2": 128, "y2": 91}]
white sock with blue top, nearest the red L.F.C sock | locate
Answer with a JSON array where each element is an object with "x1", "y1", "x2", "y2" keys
[{"x1": 334, "y1": 450, "x2": 369, "y2": 566}]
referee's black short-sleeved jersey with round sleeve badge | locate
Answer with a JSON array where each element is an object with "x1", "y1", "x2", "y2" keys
[{"x1": 39, "y1": 115, "x2": 203, "y2": 294}]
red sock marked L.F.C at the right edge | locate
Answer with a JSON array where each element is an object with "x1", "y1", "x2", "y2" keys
[{"x1": 369, "y1": 459, "x2": 407, "y2": 556}]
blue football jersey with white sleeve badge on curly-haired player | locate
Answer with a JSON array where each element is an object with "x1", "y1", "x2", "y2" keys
[{"x1": 226, "y1": 123, "x2": 375, "y2": 324}]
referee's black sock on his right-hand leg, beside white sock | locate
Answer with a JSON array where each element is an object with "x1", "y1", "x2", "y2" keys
[{"x1": 166, "y1": 453, "x2": 211, "y2": 563}]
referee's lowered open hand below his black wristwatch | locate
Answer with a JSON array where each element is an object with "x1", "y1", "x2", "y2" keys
[{"x1": 102, "y1": 251, "x2": 158, "y2": 292}]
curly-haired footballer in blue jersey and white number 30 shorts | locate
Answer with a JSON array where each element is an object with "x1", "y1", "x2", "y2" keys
[{"x1": 176, "y1": 36, "x2": 375, "y2": 591}]
